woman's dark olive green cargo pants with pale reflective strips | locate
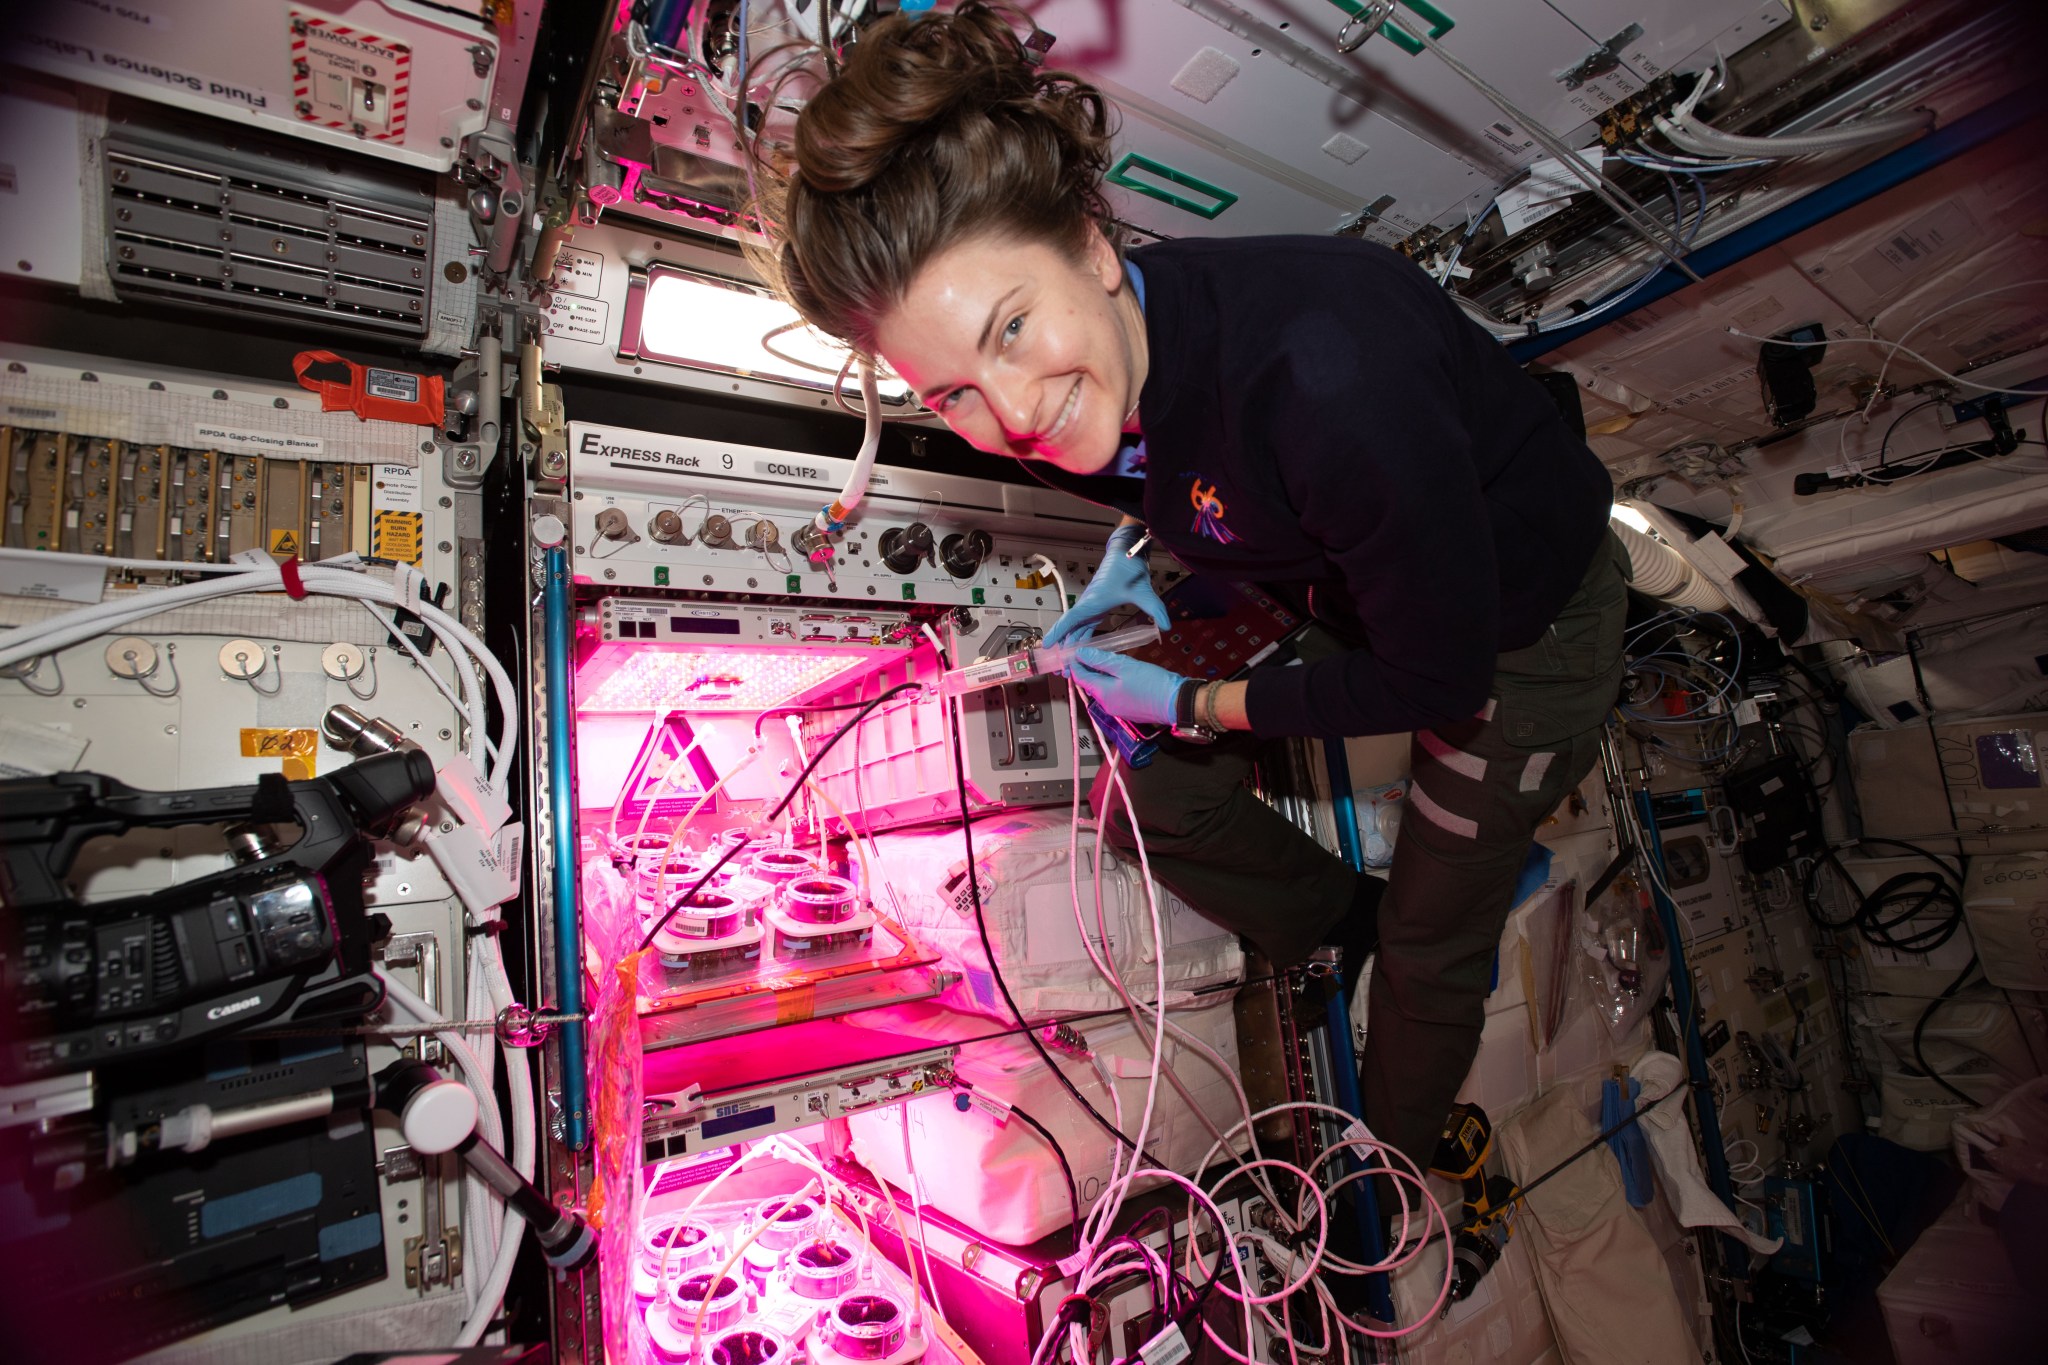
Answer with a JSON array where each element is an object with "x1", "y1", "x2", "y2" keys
[{"x1": 1090, "y1": 536, "x2": 1628, "y2": 1166}]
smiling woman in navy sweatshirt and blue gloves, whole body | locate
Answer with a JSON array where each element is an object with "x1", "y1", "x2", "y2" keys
[{"x1": 745, "y1": 2, "x2": 1624, "y2": 1160}]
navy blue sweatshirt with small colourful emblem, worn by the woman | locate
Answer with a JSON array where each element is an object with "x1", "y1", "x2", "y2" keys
[{"x1": 1030, "y1": 237, "x2": 1614, "y2": 739}]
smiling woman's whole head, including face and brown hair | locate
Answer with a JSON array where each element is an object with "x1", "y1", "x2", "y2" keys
[{"x1": 762, "y1": 4, "x2": 1145, "y2": 475}]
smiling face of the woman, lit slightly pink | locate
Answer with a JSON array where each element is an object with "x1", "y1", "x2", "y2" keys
[{"x1": 874, "y1": 231, "x2": 1145, "y2": 475}]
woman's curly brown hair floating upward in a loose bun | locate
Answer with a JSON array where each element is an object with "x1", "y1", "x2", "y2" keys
[{"x1": 756, "y1": 0, "x2": 1116, "y2": 354}]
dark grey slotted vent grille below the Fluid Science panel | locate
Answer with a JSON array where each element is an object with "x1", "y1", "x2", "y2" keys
[{"x1": 104, "y1": 141, "x2": 434, "y2": 338}]
